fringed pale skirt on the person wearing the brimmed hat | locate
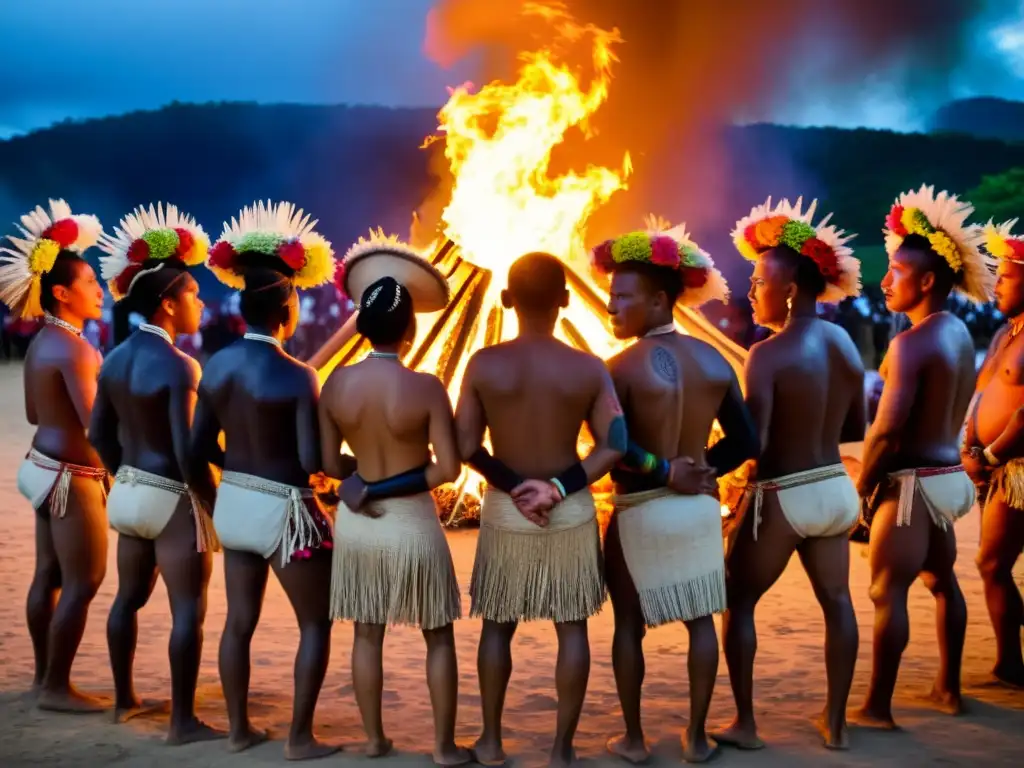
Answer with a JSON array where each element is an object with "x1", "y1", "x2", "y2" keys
[{"x1": 331, "y1": 493, "x2": 462, "y2": 630}]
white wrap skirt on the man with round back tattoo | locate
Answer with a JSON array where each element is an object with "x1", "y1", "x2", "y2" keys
[{"x1": 613, "y1": 488, "x2": 726, "y2": 627}]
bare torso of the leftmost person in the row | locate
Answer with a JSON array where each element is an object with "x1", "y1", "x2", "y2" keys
[{"x1": 25, "y1": 326, "x2": 102, "y2": 467}]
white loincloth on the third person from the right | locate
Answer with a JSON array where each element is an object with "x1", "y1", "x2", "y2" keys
[{"x1": 746, "y1": 463, "x2": 860, "y2": 541}]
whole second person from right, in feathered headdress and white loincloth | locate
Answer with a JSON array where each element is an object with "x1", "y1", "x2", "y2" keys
[{"x1": 855, "y1": 185, "x2": 993, "y2": 728}]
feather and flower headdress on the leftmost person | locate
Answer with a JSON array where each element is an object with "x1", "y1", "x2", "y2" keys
[{"x1": 0, "y1": 200, "x2": 103, "y2": 317}]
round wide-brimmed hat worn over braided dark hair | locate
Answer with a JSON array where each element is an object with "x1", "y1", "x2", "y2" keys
[{"x1": 334, "y1": 227, "x2": 451, "y2": 312}]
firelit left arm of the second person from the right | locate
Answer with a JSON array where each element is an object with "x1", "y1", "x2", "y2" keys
[{"x1": 857, "y1": 336, "x2": 918, "y2": 497}]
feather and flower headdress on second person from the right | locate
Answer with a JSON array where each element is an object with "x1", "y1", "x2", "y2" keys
[{"x1": 884, "y1": 184, "x2": 994, "y2": 304}]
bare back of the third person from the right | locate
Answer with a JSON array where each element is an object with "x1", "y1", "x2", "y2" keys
[{"x1": 745, "y1": 318, "x2": 864, "y2": 479}]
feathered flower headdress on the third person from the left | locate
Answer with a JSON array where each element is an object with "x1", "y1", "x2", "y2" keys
[{"x1": 206, "y1": 201, "x2": 335, "y2": 290}]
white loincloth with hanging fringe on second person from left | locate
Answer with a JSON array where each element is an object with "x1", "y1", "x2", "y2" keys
[{"x1": 106, "y1": 466, "x2": 219, "y2": 552}]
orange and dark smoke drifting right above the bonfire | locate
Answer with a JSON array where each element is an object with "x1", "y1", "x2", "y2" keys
[{"x1": 424, "y1": 0, "x2": 1019, "y2": 247}]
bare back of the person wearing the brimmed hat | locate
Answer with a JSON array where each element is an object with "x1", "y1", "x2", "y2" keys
[{"x1": 321, "y1": 358, "x2": 451, "y2": 482}]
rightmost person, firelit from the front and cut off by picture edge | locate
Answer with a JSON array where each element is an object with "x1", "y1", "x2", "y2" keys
[{"x1": 961, "y1": 220, "x2": 1024, "y2": 688}]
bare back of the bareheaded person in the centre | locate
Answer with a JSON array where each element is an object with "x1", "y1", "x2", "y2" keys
[{"x1": 460, "y1": 336, "x2": 607, "y2": 478}]
